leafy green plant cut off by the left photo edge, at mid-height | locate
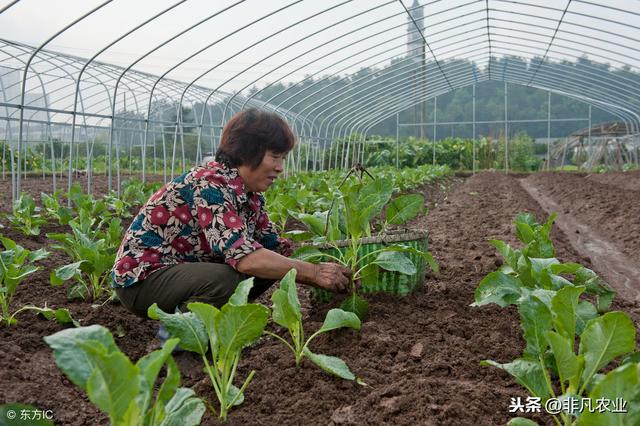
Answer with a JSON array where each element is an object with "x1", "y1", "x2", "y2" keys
[{"x1": 0, "y1": 237, "x2": 49, "y2": 325}]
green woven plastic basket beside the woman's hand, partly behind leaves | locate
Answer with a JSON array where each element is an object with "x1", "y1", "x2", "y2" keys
[{"x1": 314, "y1": 230, "x2": 429, "y2": 300}]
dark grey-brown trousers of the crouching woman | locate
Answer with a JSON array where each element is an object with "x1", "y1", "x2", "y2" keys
[{"x1": 116, "y1": 262, "x2": 275, "y2": 318}]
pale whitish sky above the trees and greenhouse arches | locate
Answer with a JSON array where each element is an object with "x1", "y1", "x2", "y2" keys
[{"x1": 0, "y1": 0, "x2": 640, "y2": 95}]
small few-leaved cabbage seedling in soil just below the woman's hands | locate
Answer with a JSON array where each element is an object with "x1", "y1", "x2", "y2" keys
[{"x1": 265, "y1": 269, "x2": 362, "y2": 384}]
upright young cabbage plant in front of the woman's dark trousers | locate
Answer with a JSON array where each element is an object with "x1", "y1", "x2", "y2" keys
[{"x1": 148, "y1": 278, "x2": 269, "y2": 421}]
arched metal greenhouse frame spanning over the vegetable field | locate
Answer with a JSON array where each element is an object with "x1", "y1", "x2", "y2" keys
[{"x1": 0, "y1": 0, "x2": 640, "y2": 199}]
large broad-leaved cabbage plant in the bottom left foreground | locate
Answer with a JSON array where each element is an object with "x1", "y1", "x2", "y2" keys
[{"x1": 44, "y1": 325, "x2": 206, "y2": 426}]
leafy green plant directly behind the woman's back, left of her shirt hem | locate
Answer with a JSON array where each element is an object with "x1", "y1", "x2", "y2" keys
[{"x1": 47, "y1": 218, "x2": 122, "y2": 300}]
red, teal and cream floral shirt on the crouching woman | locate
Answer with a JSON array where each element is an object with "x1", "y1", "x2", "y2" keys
[{"x1": 112, "y1": 161, "x2": 291, "y2": 288}]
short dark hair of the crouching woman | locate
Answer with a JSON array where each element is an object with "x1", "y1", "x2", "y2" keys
[{"x1": 216, "y1": 108, "x2": 296, "y2": 169}]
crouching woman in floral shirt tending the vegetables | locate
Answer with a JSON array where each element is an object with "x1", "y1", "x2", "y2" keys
[{"x1": 112, "y1": 109, "x2": 351, "y2": 317}]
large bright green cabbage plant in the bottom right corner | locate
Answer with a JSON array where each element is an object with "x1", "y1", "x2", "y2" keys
[{"x1": 481, "y1": 286, "x2": 640, "y2": 426}]
